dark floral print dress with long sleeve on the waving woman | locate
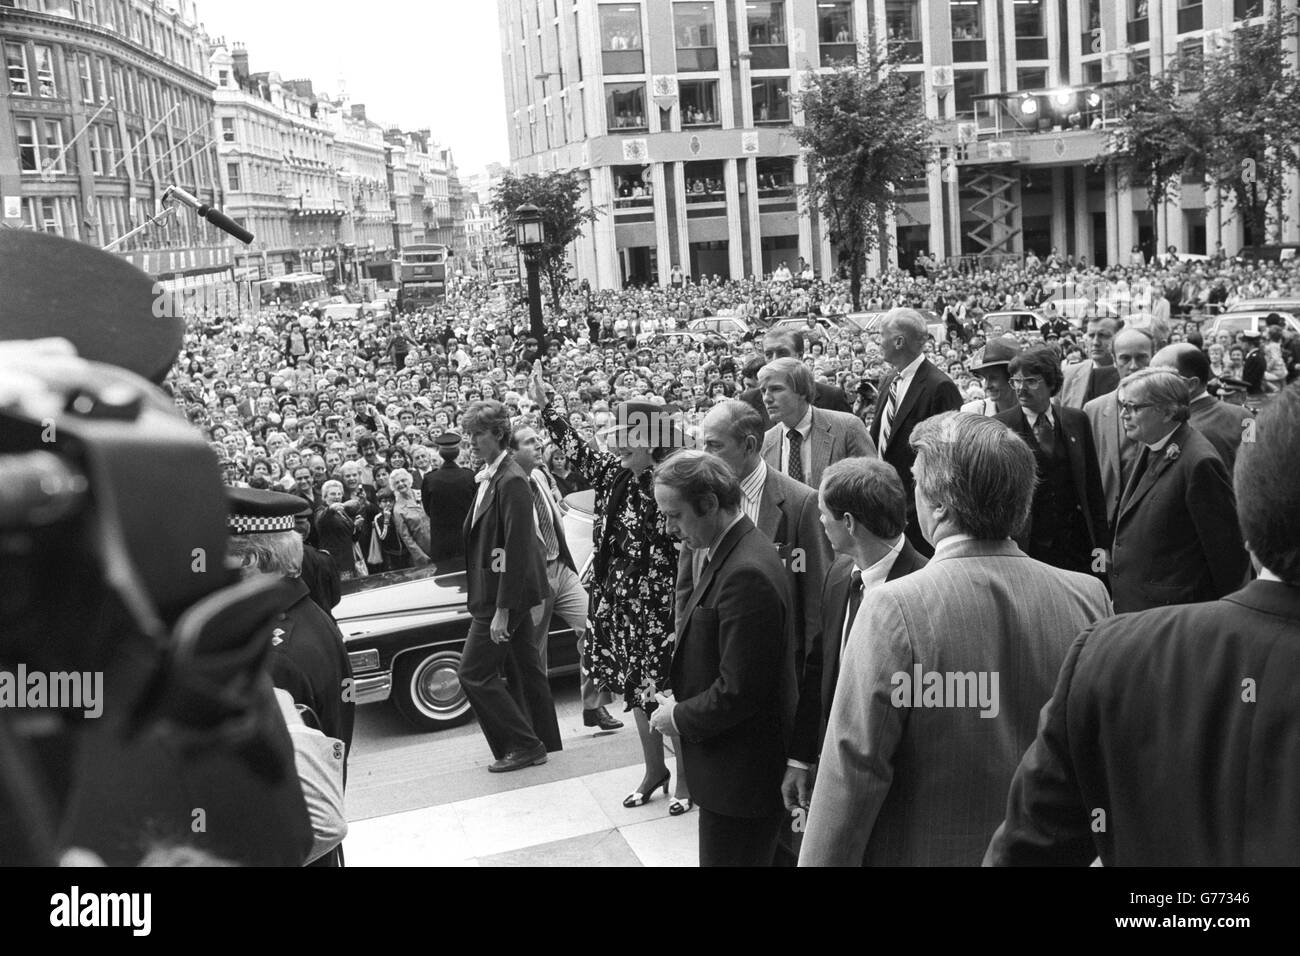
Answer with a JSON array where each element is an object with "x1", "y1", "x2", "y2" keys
[{"x1": 542, "y1": 406, "x2": 679, "y2": 709}]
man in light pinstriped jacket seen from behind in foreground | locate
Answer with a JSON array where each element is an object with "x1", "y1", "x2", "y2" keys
[{"x1": 800, "y1": 412, "x2": 1110, "y2": 866}]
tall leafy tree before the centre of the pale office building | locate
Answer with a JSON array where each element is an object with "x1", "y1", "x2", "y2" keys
[{"x1": 794, "y1": 44, "x2": 935, "y2": 308}]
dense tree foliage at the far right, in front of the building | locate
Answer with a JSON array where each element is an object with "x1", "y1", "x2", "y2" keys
[{"x1": 1099, "y1": 14, "x2": 1300, "y2": 242}]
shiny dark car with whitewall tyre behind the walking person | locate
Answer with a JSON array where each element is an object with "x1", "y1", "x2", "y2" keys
[{"x1": 334, "y1": 490, "x2": 595, "y2": 731}]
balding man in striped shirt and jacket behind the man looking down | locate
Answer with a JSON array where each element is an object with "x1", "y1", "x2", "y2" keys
[{"x1": 677, "y1": 398, "x2": 831, "y2": 671}]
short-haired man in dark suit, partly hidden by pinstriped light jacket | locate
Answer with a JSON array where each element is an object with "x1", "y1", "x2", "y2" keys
[{"x1": 781, "y1": 458, "x2": 926, "y2": 827}]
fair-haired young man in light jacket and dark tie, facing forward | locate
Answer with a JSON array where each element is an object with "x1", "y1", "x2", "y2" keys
[{"x1": 758, "y1": 359, "x2": 876, "y2": 494}]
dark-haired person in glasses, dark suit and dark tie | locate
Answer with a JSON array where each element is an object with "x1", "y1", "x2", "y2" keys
[{"x1": 993, "y1": 346, "x2": 1110, "y2": 574}]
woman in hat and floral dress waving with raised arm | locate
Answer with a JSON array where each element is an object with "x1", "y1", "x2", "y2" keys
[{"x1": 529, "y1": 363, "x2": 690, "y2": 816}]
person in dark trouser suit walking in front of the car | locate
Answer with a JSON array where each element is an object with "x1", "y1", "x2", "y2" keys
[{"x1": 458, "y1": 401, "x2": 558, "y2": 773}]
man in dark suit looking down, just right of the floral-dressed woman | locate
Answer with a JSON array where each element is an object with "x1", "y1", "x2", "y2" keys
[{"x1": 650, "y1": 451, "x2": 794, "y2": 866}]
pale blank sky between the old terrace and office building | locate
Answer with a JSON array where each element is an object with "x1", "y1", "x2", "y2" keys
[{"x1": 196, "y1": 0, "x2": 510, "y2": 177}]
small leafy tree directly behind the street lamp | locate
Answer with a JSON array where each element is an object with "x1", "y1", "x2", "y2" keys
[{"x1": 491, "y1": 169, "x2": 597, "y2": 310}]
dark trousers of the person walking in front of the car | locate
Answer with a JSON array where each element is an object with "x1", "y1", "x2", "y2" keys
[{"x1": 458, "y1": 611, "x2": 543, "y2": 760}]
